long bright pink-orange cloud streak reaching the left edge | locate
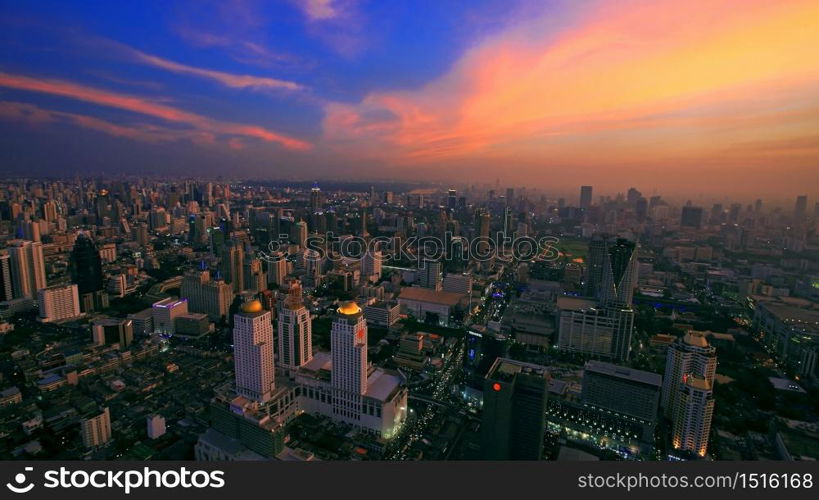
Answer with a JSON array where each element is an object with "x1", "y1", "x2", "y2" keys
[{"x1": 0, "y1": 73, "x2": 312, "y2": 150}]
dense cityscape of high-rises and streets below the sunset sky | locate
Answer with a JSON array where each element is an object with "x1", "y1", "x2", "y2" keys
[{"x1": 0, "y1": 176, "x2": 819, "y2": 461}]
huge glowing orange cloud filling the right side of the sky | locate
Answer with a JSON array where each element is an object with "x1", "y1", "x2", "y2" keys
[{"x1": 324, "y1": 0, "x2": 819, "y2": 176}]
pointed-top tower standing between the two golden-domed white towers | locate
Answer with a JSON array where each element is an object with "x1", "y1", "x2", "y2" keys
[{"x1": 278, "y1": 281, "x2": 313, "y2": 372}]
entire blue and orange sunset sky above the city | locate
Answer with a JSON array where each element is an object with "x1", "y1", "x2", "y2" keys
[{"x1": 0, "y1": 0, "x2": 819, "y2": 198}]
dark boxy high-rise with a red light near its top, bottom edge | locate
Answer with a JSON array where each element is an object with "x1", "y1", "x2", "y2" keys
[{"x1": 481, "y1": 358, "x2": 548, "y2": 460}]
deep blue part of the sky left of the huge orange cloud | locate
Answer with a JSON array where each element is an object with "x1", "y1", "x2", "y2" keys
[{"x1": 0, "y1": 0, "x2": 513, "y2": 168}]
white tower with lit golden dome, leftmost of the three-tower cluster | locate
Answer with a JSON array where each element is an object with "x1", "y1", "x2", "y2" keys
[{"x1": 233, "y1": 300, "x2": 275, "y2": 403}]
